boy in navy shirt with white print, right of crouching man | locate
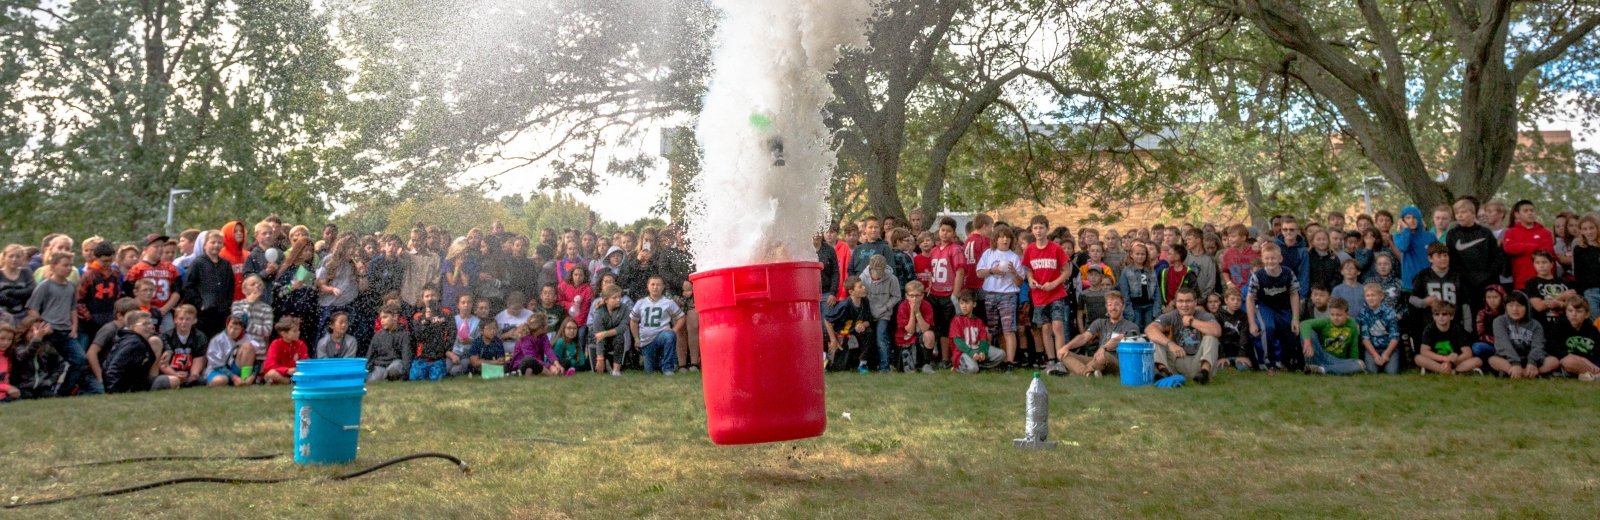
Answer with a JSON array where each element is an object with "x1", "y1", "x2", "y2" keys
[{"x1": 1245, "y1": 243, "x2": 1299, "y2": 370}]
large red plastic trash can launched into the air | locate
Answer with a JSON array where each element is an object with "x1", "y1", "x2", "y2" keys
[{"x1": 690, "y1": 262, "x2": 827, "y2": 445}]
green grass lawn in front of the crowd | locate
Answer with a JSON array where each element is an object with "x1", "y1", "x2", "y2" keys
[{"x1": 0, "y1": 373, "x2": 1600, "y2": 518}]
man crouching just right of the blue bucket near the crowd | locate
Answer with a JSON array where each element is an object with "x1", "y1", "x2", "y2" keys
[{"x1": 1144, "y1": 284, "x2": 1222, "y2": 384}]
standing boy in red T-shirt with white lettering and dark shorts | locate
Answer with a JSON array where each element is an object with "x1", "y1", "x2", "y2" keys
[{"x1": 1024, "y1": 214, "x2": 1072, "y2": 371}]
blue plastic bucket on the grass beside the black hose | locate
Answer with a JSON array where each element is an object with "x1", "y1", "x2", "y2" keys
[{"x1": 293, "y1": 358, "x2": 366, "y2": 464}]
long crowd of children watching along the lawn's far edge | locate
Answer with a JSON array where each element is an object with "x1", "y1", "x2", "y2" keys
[{"x1": 0, "y1": 197, "x2": 1600, "y2": 400}]
